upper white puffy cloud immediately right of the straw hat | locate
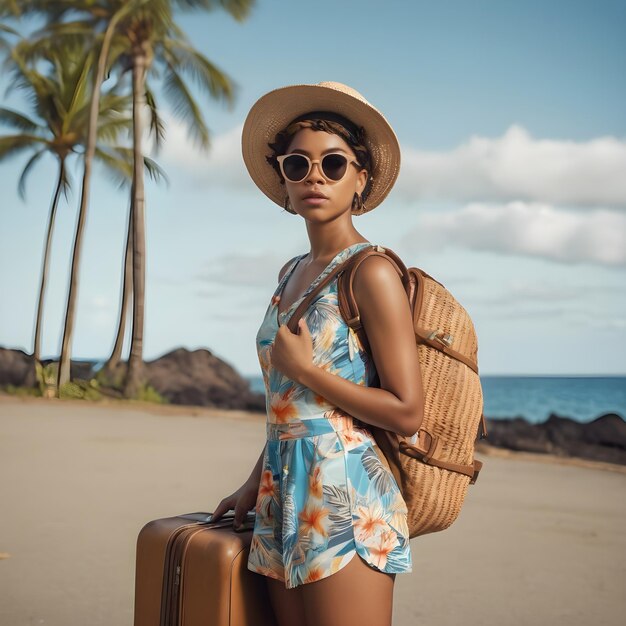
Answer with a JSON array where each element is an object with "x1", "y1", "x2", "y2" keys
[{"x1": 394, "y1": 124, "x2": 626, "y2": 208}]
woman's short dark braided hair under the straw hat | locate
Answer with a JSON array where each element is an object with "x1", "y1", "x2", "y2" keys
[{"x1": 265, "y1": 111, "x2": 373, "y2": 202}]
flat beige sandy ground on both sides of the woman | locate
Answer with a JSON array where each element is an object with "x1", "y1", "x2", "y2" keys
[{"x1": 0, "y1": 395, "x2": 626, "y2": 626}]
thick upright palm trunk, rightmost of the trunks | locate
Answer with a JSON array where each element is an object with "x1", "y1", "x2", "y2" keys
[{"x1": 124, "y1": 52, "x2": 147, "y2": 398}]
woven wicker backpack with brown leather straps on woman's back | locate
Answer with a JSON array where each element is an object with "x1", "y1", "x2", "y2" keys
[{"x1": 288, "y1": 244, "x2": 487, "y2": 538}]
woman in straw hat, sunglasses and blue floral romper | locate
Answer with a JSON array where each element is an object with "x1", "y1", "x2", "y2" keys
[{"x1": 208, "y1": 82, "x2": 423, "y2": 626}]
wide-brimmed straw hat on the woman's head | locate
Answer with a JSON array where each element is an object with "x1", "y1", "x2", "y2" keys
[{"x1": 241, "y1": 81, "x2": 400, "y2": 213}]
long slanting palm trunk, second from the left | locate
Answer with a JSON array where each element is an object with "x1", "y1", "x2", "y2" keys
[{"x1": 57, "y1": 17, "x2": 123, "y2": 395}]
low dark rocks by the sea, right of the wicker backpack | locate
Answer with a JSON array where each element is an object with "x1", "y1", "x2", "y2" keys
[{"x1": 479, "y1": 413, "x2": 626, "y2": 465}]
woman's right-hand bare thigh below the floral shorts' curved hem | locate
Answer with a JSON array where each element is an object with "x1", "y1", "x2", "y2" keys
[{"x1": 298, "y1": 554, "x2": 396, "y2": 626}]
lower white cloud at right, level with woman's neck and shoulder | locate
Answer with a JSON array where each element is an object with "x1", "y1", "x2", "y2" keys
[{"x1": 403, "y1": 202, "x2": 626, "y2": 266}]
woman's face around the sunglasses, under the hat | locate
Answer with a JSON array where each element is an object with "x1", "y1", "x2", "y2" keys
[{"x1": 285, "y1": 128, "x2": 367, "y2": 219}]
